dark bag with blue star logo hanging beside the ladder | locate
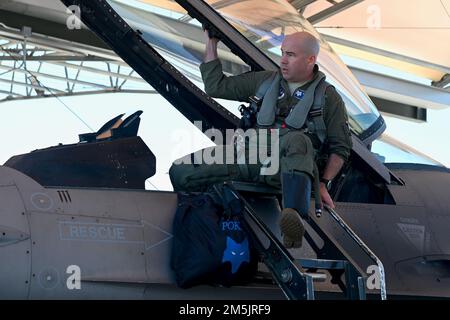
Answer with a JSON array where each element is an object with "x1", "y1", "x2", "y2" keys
[{"x1": 171, "y1": 188, "x2": 257, "y2": 288}]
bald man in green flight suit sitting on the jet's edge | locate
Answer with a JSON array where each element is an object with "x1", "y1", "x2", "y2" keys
[{"x1": 169, "y1": 30, "x2": 351, "y2": 248}]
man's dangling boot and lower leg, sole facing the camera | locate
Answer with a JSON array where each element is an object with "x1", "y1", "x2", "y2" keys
[{"x1": 280, "y1": 173, "x2": 311, "y2": 248}]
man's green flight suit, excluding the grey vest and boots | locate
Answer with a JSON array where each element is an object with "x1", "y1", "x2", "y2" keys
[{"x1": 169, "y1": 59, "x2": 351, "y2": 191}]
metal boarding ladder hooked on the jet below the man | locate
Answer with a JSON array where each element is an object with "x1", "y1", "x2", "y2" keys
[{"x1": 216, "y1": 181, "x2": 386, "y2": 300}]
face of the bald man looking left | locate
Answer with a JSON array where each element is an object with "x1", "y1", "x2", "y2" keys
[{"x1": 280, "y1": 36, "x2": 316, "y2": 82}]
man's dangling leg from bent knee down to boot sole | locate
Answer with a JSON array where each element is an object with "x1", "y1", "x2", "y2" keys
[{"x1": 280, "y1": 131, "x2": 314, "y2": 248}]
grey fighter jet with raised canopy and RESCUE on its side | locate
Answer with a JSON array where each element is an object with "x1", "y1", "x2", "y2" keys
[{"x1": 0, "y1": 0, "x2": 450, "y2": 299}]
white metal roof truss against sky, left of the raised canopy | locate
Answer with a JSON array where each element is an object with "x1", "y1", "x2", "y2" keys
[{"x1": 0, "y1": 25, "x2": 155, "y2": 102}]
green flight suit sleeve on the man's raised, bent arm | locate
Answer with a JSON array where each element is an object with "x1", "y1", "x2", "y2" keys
[{"x1": 200, "y1": 59, "x2": 261, "y2": 102}]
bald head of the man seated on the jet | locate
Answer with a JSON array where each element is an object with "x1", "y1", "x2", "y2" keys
[{"x1": 280, "y1": 31, "x2": 320, "y2": 82}]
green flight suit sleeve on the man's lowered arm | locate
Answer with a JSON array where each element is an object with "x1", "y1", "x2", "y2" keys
[{"x1": 324, "y1": 87, "x2": 352, "y2": 161}]
